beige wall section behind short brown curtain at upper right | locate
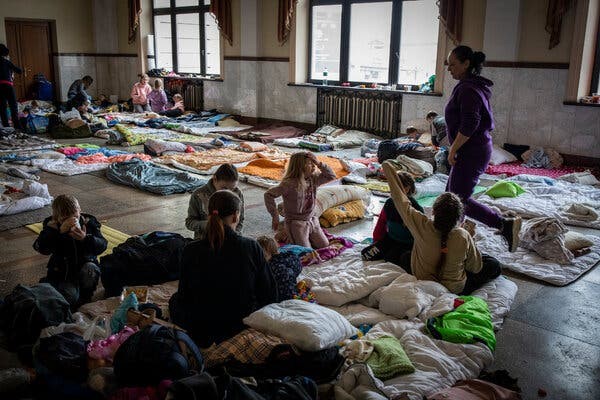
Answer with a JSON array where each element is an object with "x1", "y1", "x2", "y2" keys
[{"x1": 517, "y1": 0, "x2": 575, "y2": 63}]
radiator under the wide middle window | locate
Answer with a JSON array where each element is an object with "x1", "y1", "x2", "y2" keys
[{"x1": 317, "y1": 87, "x2": 402, "y2": 137}]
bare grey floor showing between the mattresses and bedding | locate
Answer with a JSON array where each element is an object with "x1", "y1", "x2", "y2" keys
[{"x1": 0, "y1": 139, "x2": 600, "y2": 400}]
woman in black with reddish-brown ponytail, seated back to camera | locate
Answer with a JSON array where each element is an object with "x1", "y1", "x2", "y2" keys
[{"x1": 169, "y1": 190, "x2": 277, "y2": 347}]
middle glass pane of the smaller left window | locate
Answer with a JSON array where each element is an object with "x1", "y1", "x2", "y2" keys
[{"x1": 176, "y1": 13, "x2": 200, "y2": 74}]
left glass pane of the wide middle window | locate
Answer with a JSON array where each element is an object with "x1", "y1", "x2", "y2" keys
[{"x1": 310, "y1": 5, "x2": 342, "y2": 81}]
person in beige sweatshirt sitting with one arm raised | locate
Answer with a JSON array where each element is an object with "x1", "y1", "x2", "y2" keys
[{"x1": 383, "y1": 162, "x2": 501, "y2": 294}]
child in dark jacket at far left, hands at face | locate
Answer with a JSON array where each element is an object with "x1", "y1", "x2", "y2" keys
[{"x1": 33, "y1": 194, "x2": 107, "y2": 309}]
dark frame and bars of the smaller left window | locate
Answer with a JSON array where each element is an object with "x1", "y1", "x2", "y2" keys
[{"x1": 151, "y1": 0, "x2": 222, "y2": 78}]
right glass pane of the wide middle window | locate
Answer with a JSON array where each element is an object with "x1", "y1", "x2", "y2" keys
[{"x1": 398, "y1": 0, "x2": 439, "y2": 85}]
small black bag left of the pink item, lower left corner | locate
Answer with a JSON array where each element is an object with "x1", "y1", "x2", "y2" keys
[{"x1": 36, "y1": 332, "x2": 89, "y2": 382}]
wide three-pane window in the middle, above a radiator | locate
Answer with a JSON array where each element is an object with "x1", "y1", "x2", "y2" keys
[{"x1": 309, "y1": 0, "x2": 439, "y2": 85}]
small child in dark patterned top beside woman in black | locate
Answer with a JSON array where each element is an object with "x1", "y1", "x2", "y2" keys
[{"x1": 256, "y1": 236, "x2": 302, "y2": 301}]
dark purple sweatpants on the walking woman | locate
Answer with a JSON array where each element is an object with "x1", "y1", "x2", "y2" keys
[{"x1": 446, "y1": 145, "x2": 503, "y2": 229}]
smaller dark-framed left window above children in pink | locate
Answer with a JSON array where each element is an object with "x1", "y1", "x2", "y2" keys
[{"x1": 153, "y1": 0, "x2": 221, "y2": 76}]
